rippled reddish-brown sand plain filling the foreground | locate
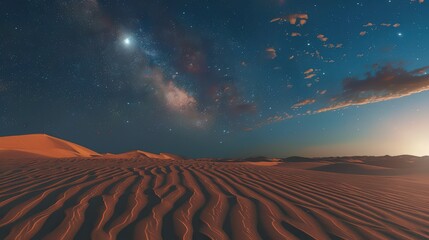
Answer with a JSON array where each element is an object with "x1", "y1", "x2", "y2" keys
[{"x1": 0, "y1": 157, "x2": 429, "y2": 240}]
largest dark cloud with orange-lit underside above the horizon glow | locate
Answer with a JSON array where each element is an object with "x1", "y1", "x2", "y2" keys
[{"x1": 315, "y1": 65, "x2": 429, "y2": 113}]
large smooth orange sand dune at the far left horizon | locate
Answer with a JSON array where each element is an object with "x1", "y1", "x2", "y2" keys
[{"x1": 0, "y1": 134, "x2": 100, "y2": 159}]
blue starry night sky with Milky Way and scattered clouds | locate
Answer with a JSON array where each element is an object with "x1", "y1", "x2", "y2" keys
[{"x1": 0, "y1": 0, "x2": 429, "y2": 157}]
